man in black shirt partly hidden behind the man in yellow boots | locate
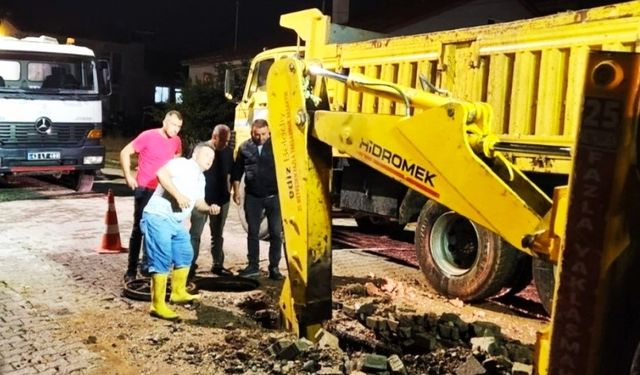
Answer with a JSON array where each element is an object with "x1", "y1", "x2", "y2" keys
[{"x1": 189, "y1": 124, "x2": 233, "y2": 278}]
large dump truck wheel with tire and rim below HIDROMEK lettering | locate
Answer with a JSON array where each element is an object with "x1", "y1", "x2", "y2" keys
[{"x1": 415, "y1": 201, "x2": 518, "y2": 301}]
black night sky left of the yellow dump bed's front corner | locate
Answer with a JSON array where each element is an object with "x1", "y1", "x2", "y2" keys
[{"x1": 0, "y1": 0, "x2": 330, "y2": 58}]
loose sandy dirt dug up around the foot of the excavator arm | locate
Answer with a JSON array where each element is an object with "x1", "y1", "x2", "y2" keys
[{"x1": 61, "y1": 275, "x2": 544, "y2": 374}]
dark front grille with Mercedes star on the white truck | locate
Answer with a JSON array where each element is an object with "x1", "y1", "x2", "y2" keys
[{"x1": 0, "y1": 123, "x2": 95, "y2": 147}]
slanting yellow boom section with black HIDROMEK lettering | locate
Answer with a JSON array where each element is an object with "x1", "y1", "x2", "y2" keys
[{"x1": 313, "y1": 104, "x2": 550, "y2": 252}]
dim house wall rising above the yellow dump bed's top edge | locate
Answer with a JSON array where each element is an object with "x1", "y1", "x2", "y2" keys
[{"x1": 390, "y1": 0, "x2": 534, "y2": 35}]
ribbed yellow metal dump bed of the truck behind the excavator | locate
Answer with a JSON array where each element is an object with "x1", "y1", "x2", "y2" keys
[{"x1": 280, "y1": 1, "x2": 640, "y2": 174}]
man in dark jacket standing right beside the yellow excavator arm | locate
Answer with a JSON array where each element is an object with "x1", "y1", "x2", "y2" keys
[{"x1": 231, "y1": 119, "x2": 283, "y2": 280}]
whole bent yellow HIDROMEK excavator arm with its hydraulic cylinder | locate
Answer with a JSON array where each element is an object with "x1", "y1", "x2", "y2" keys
[{"x1": 267, "y1": 54, "x2": 551, "y2": 334}]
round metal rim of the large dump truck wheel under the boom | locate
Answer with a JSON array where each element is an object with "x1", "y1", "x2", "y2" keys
[{"x1": 429, "y1": 211, "x2": 479, "y2": 276}]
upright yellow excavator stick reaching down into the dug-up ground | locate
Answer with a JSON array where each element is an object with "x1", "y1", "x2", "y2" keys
[{"x1": 267, "y1": 59, "x2": 331, "y2": 339}]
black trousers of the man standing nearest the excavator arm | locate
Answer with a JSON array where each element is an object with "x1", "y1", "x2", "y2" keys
[{"x1": 244, "y1": 194, "x2": 282, "y2": 272}]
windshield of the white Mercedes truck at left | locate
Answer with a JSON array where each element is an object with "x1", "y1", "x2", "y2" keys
[{"x1": 0, "y1": 52, "x2": 98, "y2": 95}]
